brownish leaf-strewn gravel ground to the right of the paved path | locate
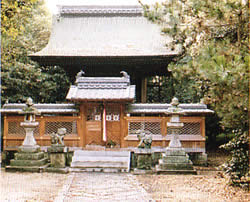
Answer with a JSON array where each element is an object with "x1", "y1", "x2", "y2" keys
[{"x1": 137, "y1": 171, "x2": 250, "y2": 202}]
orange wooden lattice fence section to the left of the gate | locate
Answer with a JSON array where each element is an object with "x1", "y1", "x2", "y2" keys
[{"x1": 3, "y1": 116, "x2": 80, "y2": 150}]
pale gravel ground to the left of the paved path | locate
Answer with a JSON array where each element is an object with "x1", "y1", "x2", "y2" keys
[{"x1": 0, "y1": 168, "x2": 68, "y2": 202}]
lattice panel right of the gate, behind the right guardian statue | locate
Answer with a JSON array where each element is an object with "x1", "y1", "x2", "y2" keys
[{"x1": 128, "y1": 122, "x2": 161, "y2": 135}]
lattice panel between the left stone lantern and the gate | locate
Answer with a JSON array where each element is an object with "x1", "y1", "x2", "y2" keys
[{"x1": 45, "y1": 121, "x2": 77, "y2": 135}]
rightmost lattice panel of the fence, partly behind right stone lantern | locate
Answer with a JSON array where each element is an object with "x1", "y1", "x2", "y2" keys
[{"x1": 167, "y1": 122, "x2": 201, "y2": 135}]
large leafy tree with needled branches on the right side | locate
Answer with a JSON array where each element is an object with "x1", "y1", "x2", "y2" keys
[{"x1": 144, "y1": 0, "x2": 249, "y2": 186}]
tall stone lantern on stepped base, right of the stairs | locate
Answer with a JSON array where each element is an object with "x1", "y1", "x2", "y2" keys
[{"x1": 156, "y1": 98, "x2": 196, "y2": 174}]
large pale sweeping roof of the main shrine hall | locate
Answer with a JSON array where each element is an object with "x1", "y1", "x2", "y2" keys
[{"x1": 30, "y1": 1, "x2": 178, "y2": 61}]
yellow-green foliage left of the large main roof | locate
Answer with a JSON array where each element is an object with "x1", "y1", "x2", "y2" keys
[{"x1": 1, "y1": 0, "x2": 69, "y2": 103}]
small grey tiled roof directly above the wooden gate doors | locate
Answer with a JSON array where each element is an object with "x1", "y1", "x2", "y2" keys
[{"x1": 66, "y1": 72, "x2": 135, "y2": 101}]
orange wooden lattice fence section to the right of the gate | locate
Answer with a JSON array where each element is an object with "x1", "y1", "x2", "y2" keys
[{"x1": 124, "y1": 117, "x2": 205, "y2": 152}]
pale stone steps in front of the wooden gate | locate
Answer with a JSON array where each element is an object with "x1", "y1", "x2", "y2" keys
[{"x1": 70, "y1": 150, "x2": 130, "y2": 172}]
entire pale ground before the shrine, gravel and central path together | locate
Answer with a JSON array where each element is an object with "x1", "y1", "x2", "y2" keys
[{"x1": 0, "y1": 169, "x2": 250, "y2": 202}]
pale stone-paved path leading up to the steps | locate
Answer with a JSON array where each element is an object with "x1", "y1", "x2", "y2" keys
[{"x1": 55, "y1": 173, "x2": 154, "y2": 202}]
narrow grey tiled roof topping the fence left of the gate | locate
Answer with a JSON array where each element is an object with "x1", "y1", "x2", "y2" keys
[{"x1": 0, "y1": 103, "x2": 78, "y2": 114}]
